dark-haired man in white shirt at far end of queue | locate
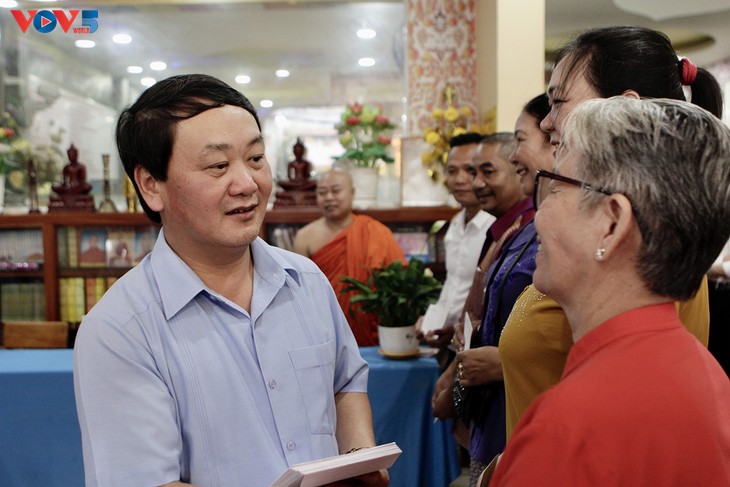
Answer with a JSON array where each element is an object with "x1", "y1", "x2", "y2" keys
[{"x1": 418, "y1": 132, "x2": 495, "y2": 362}]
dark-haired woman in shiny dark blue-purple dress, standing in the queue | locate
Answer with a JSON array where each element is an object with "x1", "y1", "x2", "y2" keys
[{"x1": 434, "y1": 94, "x2": 553, "y2": 485}]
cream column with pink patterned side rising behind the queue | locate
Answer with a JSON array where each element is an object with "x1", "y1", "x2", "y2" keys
[{"x1": 406, "y1": 0, "x2": 545, "y2": 135}]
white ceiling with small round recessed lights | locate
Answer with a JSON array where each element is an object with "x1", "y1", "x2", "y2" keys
[{"x1": 8, "y1": 0, "x2": 730, "y2": 107}]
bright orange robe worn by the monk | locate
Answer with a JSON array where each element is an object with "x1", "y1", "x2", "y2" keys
[{"x1": 312, "y1": 215, "x2": 406, "y2": 347}]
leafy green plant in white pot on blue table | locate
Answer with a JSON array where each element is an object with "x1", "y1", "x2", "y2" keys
[{"x1": 341, "y1": 259, "x2": 441, "y2": 356}]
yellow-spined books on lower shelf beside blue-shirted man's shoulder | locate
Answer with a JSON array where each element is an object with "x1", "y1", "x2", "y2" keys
[{"x1": 58, "y1": 277, "x2": 117, "y2": 323}]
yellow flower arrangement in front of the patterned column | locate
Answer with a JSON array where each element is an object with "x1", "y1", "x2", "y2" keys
[{"x1": 421, "y1": 85, "x2": 481, "y2": 181}]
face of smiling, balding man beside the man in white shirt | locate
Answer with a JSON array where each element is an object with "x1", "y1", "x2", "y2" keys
[{"x1": 469, "y1": 144, "x2": 524, "y2": 218}]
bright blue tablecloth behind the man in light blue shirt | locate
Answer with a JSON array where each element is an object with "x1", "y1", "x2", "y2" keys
[{"x1": 0, "y1": 347, "x2": 459, "y2": 487}]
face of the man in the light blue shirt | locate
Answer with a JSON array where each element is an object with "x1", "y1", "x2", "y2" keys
[{"x1": 145, "y1": 105, "x2": 272, "y2": 261}]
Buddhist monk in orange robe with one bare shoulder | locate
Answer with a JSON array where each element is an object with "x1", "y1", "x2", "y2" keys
[{"x1": 294, "y1": 169, "x2": 406, "y2": 347}]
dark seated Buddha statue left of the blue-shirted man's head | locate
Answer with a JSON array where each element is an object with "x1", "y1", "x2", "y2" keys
[{"x1": 48, "y1": 144, "x2": 94, "y2": 212}]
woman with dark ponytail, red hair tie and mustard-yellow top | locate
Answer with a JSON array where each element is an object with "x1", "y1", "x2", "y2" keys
[{"x1": 499, "y1": 27, "x2": 722, "y2": 438}]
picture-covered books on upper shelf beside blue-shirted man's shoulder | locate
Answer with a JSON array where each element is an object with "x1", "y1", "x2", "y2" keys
[{"x1": 56, "y1": 226, "x2": 159, "y2": 268}]
